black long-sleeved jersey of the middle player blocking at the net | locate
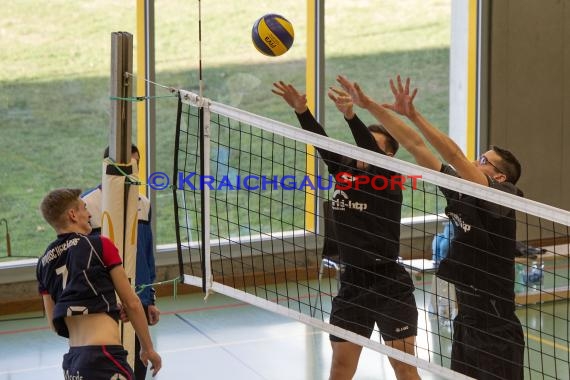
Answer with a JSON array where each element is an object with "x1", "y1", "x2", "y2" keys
[{"x1": 297, "y1": 111, "x2": 402, "y2": 268}]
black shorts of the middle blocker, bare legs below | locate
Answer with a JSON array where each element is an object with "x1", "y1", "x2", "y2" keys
[{"x1": 330, "y1": 263, "x2": 418, "y2": 342}]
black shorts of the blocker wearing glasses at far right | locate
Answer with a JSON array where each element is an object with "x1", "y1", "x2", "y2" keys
[{"x1": 451, "y1": 314, "x2": 525, "y2": 380}]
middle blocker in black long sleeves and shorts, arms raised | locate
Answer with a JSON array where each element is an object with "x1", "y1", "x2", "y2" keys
[{"x1": 272, "y1": 82, "x2": 419, "y2": 380}]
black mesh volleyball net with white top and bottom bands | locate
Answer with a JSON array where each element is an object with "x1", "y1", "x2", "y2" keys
[{"x1": 173, "y1": 91, "x2": 570, "y2": 379}]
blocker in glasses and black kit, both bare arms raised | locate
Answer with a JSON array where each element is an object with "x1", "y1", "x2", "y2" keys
[{"x1": 337, "y1": 76, "x2": 525, "y2": 380}]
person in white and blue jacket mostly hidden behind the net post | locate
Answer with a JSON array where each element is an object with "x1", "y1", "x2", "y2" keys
[{"x1": 81, "y1": 144, "x2": 160, "y2": 380}]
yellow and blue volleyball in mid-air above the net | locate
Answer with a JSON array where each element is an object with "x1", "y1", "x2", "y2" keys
[{"x1": 251, "y1": 14, "x2": 295, "y2": 57}]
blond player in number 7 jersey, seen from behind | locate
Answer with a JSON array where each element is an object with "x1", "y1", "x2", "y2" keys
[{"x1": 37, "y1": 189, "x2": 161, "y2": 380}]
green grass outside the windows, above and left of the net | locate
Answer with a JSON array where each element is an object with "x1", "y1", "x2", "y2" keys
[{"x1": 0, "y1": 0, "x2": 451, "y2": 256}]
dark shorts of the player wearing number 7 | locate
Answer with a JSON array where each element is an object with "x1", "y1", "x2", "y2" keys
[{"x1": 63, "y1": 346, "x2": 134, "y2": 380}]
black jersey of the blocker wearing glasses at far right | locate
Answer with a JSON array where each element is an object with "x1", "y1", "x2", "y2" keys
[{"x1": 438, "y1": 165, "x2": 517, "y2": 303}]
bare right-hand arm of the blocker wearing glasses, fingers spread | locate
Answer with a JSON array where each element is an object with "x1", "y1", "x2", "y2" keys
[{"x1": 384, "y1": 75, "x2": 489, "y2": 186}]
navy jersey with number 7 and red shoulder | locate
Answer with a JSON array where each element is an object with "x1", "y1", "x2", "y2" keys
[{"x1": 36, "y1": 233, "x2": 122, "y2": 338}]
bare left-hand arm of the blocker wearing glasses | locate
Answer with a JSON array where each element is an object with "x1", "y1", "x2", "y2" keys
[{"x1": 337, "y1": 75, "x2": 441, "y2": 171}]
